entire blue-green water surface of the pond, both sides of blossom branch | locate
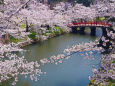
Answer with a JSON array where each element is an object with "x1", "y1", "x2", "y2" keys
[{"x1": 0, "y1": 34, "x2": 101, "y2": 86}]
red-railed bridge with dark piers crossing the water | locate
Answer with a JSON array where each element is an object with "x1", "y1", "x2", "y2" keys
[{"x1": 68, "y1": 21, "x2": 111, "y2": 36}]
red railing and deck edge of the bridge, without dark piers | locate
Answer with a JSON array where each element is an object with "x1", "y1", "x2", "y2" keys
[{"x1": 68, "y1": 21, "x2": 111, "y2": 27}]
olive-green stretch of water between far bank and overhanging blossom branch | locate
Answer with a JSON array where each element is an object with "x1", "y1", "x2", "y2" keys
[{"x1": 21, "y1": 34, "x2": 96, "y2": 61}]
